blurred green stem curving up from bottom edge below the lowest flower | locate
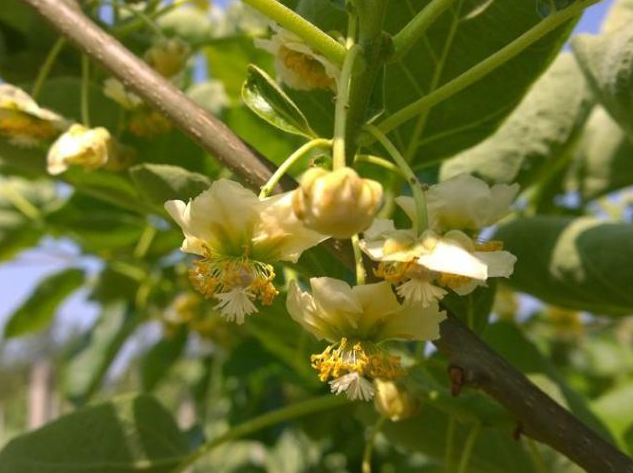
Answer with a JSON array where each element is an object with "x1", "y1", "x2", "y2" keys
[{"x1": 173, "y1": 395, "x2": 349, "y2": 473}]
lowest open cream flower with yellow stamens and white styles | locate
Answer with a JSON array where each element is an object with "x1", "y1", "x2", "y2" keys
[{"x1": 286, "y1": 277, "x2": 446, "y2": 400}]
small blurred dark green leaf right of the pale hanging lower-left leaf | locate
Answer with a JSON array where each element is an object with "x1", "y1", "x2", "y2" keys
[{"x1": 140, "y1": 326, "x2": 189, "y2": 391}]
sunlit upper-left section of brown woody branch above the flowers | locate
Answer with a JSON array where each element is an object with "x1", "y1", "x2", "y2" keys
[{"x1": 22, "y1": 0, "x2": 291, "y2": 188}]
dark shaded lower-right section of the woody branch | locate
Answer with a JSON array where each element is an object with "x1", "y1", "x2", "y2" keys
[{"x1": 436, "y1": 317, "x2": 633, "y2": 473}]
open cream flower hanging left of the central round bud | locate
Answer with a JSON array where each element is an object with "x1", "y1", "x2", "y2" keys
[{"x1": 165, "y1": 179, "x2": 326, "y2": 323}]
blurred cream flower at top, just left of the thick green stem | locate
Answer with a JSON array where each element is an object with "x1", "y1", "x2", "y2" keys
[{"x1": 255, "y1": 24, "x2": 341, "y2": 90}]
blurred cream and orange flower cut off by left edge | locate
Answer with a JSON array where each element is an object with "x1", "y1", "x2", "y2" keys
[{"x1": 0, "y1": 84, "x2": 68, "y2": 147}]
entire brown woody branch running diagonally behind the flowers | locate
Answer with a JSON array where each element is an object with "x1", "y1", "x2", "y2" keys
[{"x1": 22, "y1": 0, "x2": 633, "y2": 473}]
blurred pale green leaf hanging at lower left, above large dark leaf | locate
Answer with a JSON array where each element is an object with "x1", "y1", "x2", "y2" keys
[{"x1": 63, "y1": 302, "x2": 139, "y2": 404}]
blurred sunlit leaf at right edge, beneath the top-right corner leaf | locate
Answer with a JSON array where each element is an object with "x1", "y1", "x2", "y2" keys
[{"x1": 565, "y1": 106, "x2": 633, "y2": 202}]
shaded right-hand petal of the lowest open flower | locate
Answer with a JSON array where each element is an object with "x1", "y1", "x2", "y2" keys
[{"x1": 378, "y1": 303, "x2": 446, "y2": 340}]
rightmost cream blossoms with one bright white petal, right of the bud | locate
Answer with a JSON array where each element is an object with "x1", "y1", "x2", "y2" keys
[{"x1": 361, "y1": 174, "x2": 519, "y2": 307}]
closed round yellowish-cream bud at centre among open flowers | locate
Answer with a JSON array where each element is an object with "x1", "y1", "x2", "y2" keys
[{"x1": 292, "y1": 167, "x2": 382, "y2": 238}]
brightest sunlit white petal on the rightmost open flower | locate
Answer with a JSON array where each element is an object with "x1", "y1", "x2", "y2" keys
[{"x1": 418, "y1": 241, "x2": 488, "y2": 281}]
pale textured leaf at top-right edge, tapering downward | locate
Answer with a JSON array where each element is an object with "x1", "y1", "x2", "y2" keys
[{"x1": 572, "y1": 22, "x2": 633, "y2": 140}]
